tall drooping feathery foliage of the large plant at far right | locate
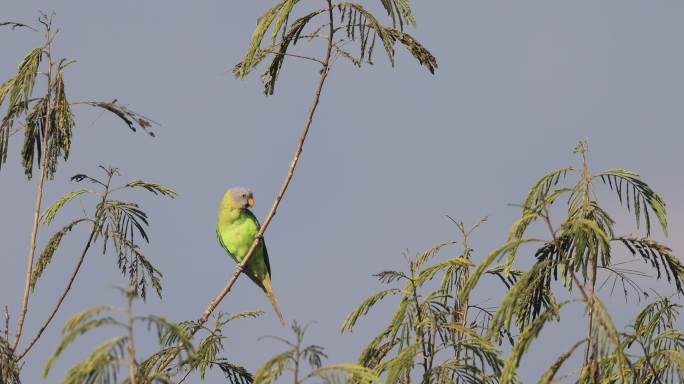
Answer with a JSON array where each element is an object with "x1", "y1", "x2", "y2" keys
[{"x1": 465, "y1": 142, "x2": 684, "y2": 383}]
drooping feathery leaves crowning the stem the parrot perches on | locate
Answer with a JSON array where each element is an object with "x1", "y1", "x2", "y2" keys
[{"x1": 233, "y1": 0, "x2": 437, "y2": 95}]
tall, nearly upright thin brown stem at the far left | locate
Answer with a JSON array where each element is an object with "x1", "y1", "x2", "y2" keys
[{"x1": 12, "y1": 29, "x2": 52, "y2": 350}]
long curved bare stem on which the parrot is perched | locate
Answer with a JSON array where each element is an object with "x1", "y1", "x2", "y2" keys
[{"x1": 154, "y1": 0, "x2": 334, "y2": 376}]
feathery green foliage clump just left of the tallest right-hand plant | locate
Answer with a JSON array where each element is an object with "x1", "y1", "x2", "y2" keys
[{"x1": 342, "y1": 219, "x2": 508, "y2": 383}]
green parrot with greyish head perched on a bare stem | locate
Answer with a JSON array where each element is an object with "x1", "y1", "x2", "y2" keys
[{"x1": 216, "y1": 188, "x2": 285, "y2": 324}]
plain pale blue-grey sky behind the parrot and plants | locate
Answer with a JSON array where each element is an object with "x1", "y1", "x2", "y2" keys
[{"x1": 0, "y1": 0, "x2": 684, "y2": 382}]
